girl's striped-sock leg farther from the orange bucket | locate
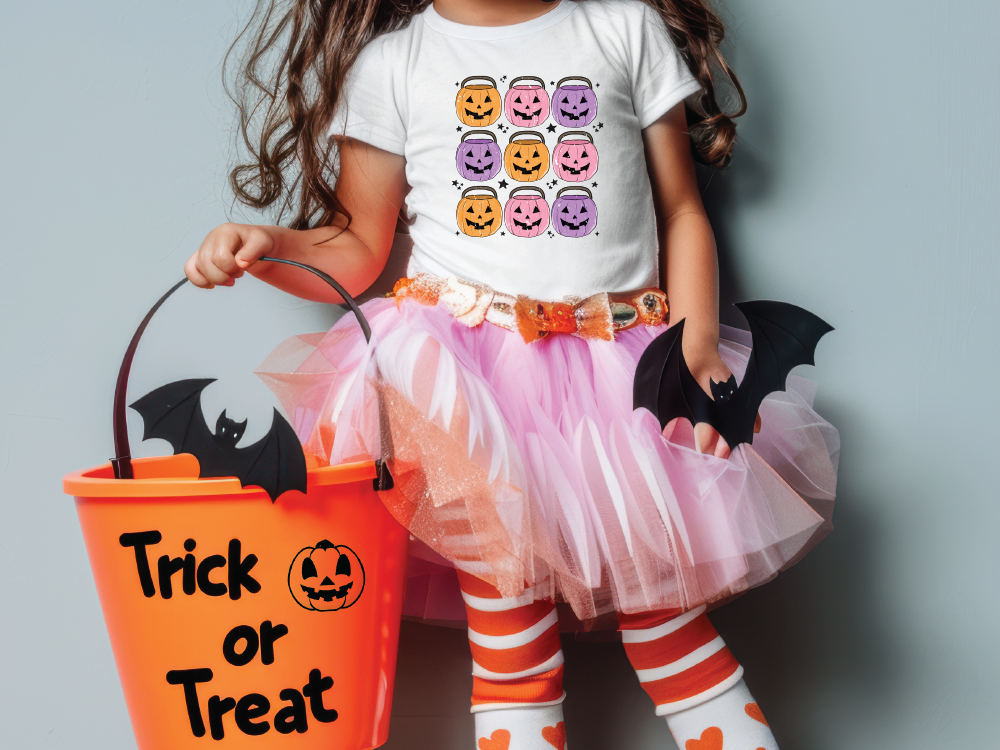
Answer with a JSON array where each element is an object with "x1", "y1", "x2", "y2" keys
[{"x1": 618, "y1": 607, "x2": 778, "y2": 750}]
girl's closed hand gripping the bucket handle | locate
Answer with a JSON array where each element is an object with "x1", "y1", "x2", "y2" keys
[{"x1": 184, "y1": 223, "x2": 275, "y2": 289}]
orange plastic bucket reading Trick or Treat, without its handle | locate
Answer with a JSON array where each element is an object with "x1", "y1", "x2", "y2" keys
[{"x1": 63, "y1": 262, "x2": 409, "y2": 750}]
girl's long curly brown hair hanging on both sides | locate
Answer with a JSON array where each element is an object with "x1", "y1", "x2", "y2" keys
[{"x1": 223, "y1": 0, "x2": 746, "y2": 229}]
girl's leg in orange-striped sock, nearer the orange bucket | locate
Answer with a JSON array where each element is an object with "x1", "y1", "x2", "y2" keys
[{"x1": 458, "y1": 571, "x2": 566, "y2": 750}]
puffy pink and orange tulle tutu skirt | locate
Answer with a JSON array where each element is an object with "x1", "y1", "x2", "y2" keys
[{"x1": 258, "y1": 299, "x2": 839, "y2": 620}]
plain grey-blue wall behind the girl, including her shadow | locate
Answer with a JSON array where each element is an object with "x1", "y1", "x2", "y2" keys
[{"x1": 0, "y1": 0, "x2": 1000, "y2": 750}]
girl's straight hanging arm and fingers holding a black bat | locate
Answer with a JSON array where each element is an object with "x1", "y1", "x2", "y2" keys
[{"x1": 642, "y1": 102, "x2": 748, "y2": 458}]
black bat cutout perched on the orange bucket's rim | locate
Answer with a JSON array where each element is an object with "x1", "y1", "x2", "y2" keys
[{"x1": 132, "y1": 379, "x2": 306, "y2": 502}]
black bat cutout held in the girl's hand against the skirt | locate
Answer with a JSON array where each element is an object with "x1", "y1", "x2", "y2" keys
[{"x1": 632, "y1": 300, "x2": 833, "y2": 448}]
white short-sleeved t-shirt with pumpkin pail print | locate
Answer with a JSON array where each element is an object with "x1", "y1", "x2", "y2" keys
[{"x1": 330, "y1": 0, "x2": 700, "y2": 300}]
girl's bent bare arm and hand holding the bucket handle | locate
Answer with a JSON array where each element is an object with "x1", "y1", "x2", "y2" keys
[{"x1": 184, "y1": 139, "x2": 406, "y2": 303}]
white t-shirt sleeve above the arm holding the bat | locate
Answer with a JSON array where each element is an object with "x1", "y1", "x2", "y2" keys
[{"x1": 629, "y1": 5, "x2": 701, "y2": 128}]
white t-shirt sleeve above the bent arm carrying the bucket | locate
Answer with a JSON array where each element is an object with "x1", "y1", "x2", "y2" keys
[{"x1": 328, "y1": 40, "x2": 406, "y2": 155}]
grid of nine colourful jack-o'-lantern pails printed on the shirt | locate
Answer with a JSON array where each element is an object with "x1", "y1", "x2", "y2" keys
[{"x1": 451, "y1": 73, "x2": 604, "y2": 239}]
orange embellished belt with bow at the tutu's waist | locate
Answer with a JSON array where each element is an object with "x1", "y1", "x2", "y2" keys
[{"x1": 392, "y1": 273, "x2": 669, "y2": 344}]
